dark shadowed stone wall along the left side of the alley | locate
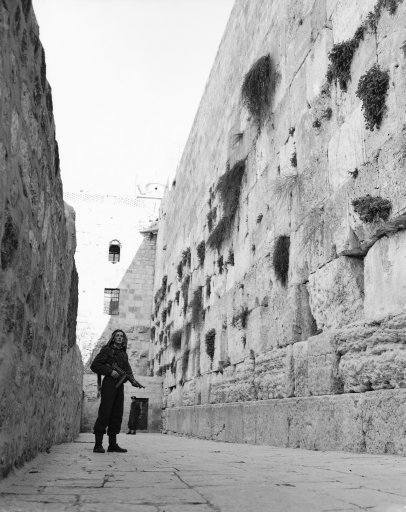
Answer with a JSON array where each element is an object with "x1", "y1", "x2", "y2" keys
[{"x1": 0, "y1": 0, "x2": 83, "y2": 477}]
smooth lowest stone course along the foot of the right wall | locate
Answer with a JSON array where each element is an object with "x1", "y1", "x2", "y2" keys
[{"x1": 163, "y1": 389, "x2": 406, "y2": 455}]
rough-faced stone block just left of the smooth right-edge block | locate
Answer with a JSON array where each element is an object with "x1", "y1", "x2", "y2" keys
[{"x1": 308, "y1": 256, "x2": 364, "y2": 329}]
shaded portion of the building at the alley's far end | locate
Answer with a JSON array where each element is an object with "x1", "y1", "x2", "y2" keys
[{"x1": 82, "y1": 230, "x2": 162, "y2": 432}]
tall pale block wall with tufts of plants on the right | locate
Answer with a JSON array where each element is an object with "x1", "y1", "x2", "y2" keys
[{"x1": 151, "y1": 0, "x2": 406, "y2": 454}]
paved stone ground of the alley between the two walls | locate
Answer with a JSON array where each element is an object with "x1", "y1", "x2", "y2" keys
[{"x1": 0, "y1": 434, "x2": 406, "y2": 512}]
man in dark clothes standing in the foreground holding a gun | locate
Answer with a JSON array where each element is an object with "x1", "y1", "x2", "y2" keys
[{"x1": 90, "y1": 329, "x2": 144, "y2": 453}]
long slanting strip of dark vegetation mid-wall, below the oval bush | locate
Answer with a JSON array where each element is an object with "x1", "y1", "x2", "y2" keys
[{"x1": 207, "y1": 160, "x2": 245, "y2": 250}]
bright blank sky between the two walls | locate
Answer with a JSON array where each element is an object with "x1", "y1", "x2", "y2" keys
[{"x1": 33, "y1": 0, "x2": 233, "y2": 195}]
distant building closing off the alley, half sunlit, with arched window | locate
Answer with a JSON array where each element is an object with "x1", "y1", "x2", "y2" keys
[{"x1": 66, "y1": 192, "x2": 161, "y2": 430}]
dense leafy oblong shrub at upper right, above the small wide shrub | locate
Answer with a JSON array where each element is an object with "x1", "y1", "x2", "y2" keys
[{"x1": 357, "y1": 64, "x2": 389, "y2": 130}]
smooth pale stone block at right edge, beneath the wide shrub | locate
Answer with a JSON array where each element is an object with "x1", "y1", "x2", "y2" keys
[{"x1": 364, "y1": 231, "x2": 406, "y2": 320}]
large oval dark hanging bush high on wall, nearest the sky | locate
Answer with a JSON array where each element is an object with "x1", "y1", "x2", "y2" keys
[{"x1": 241, "y1": 55, "x2": 275, "y2": 128}]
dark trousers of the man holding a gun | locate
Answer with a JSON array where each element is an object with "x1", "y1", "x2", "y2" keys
[{"x1": 94, "y1": 376, "x2": 124, "y2": 434}]
